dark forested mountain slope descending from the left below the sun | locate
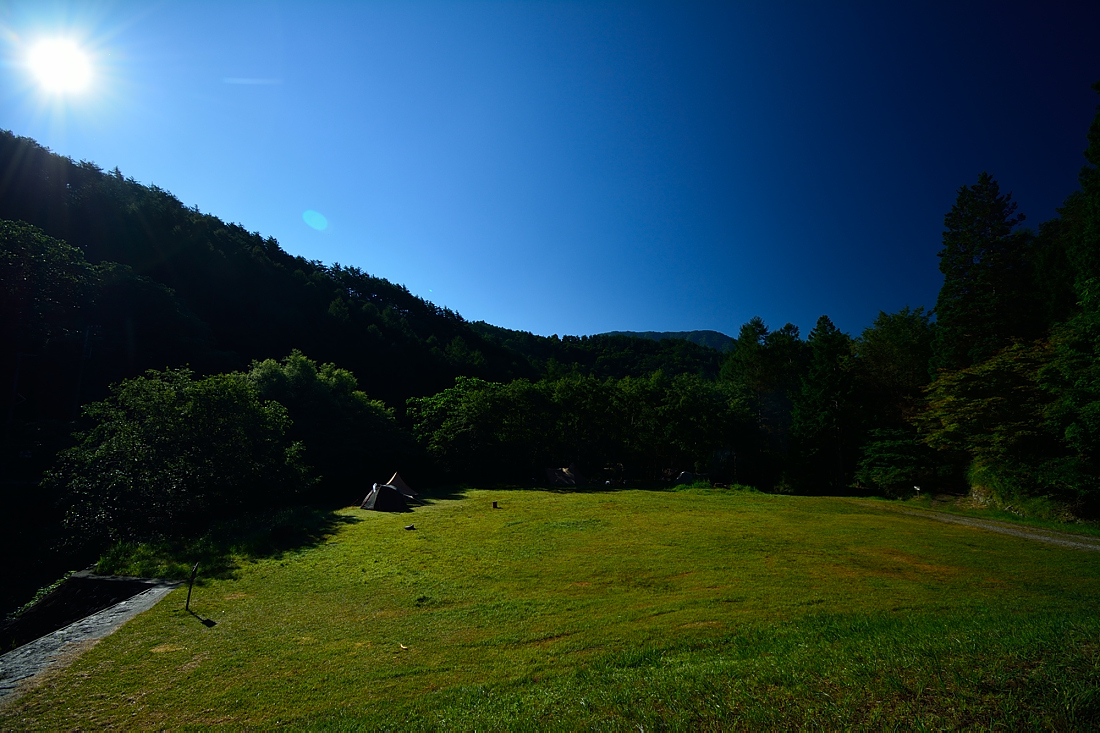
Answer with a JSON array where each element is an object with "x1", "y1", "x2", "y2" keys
[{"x1": 0, "y1": 132, "x2": 530, "y2": 409}]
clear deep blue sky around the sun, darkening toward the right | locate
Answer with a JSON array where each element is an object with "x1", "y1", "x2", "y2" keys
[{"x1": 0, "y1": 0, "x2": 1100, "y2": 335}]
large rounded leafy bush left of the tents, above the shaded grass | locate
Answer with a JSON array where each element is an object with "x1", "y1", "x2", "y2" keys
[{"x1": 45, "y1": 369, "x2": 312, "y2": 543}]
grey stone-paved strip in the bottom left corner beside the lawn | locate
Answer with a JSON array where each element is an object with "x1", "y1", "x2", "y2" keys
[{"x1": 0, "y1": 581, "x2": 179, "y2": 704}]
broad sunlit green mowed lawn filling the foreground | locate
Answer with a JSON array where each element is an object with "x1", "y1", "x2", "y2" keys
[{"x1": 0, "y1": 490, "x2": 1100, "y2": 730}]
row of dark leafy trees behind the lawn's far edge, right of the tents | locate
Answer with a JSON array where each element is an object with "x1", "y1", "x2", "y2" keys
[{"x1": 408, "y1": 372, "x2": 754, "y2": 483}]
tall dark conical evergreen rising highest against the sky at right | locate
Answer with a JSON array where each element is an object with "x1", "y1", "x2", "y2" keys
[{"x1": 932, "y1": 173, "x2": 1036, "y2": 370}]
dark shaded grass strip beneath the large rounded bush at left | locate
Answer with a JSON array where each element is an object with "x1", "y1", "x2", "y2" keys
[{"x1": 96, "y1": 506, "x2": 362, "y2": 586}]
